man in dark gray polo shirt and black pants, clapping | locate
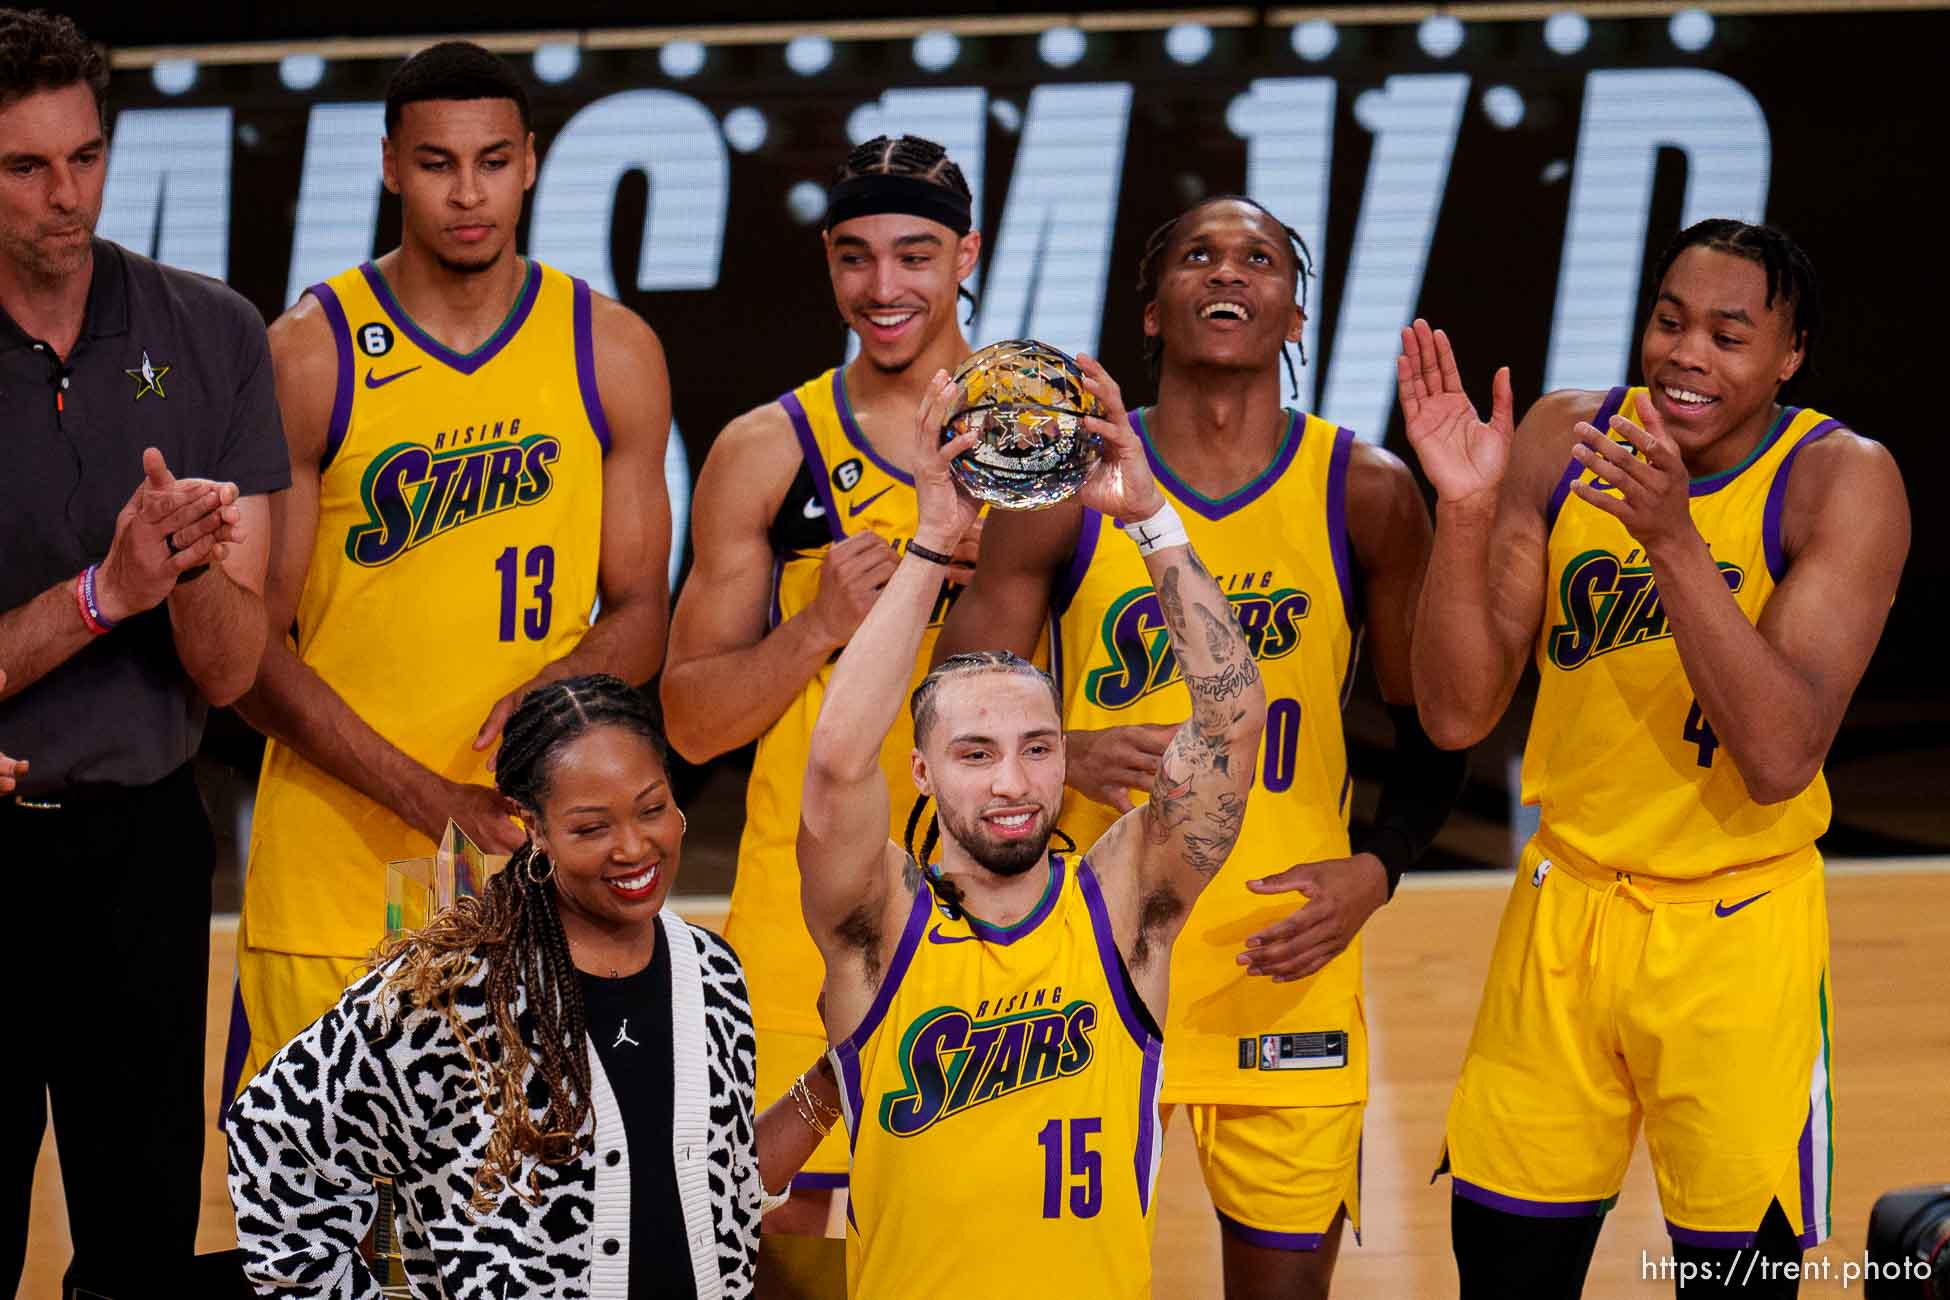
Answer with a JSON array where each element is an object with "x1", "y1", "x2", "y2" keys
[{"x1": 0, "y1": 10, "x2": 291, "y2": 1300}]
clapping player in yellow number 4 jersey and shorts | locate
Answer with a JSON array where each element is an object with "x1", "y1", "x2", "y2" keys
[{"x1": 1400, "y1": 220, "x2": 1909, "y2": 1298}]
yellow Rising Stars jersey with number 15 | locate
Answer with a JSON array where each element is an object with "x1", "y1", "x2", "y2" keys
[{"x1": 833, "y1": 856, "x2": 1164, "y2": 1300}]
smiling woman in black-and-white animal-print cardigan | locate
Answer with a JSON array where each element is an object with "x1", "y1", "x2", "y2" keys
[{"x1": 230, "y1": 676, "x2": 839, "y2": 1296}]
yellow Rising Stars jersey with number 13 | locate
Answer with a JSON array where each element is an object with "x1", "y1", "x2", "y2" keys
[{"x1": 244, "y1": 261, "x2": 608, "y2": 957}]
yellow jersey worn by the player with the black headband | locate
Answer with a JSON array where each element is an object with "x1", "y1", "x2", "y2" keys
[{"x1": 725, "y1": 368, "x2": 961, "y2": 1037}]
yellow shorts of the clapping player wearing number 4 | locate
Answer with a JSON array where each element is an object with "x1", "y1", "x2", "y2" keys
[{"x1": 1439, "y1": 832, "x2": 1833, "y2": 1249}]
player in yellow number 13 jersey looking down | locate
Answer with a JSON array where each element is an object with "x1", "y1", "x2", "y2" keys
[{"x1": 232, "y1": 43, "x2": 671, "y2": 1072}]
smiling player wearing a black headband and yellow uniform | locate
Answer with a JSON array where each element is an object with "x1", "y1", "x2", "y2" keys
[{"x1": 663, "y1": 136, "x2": 981, "y2": 1236}]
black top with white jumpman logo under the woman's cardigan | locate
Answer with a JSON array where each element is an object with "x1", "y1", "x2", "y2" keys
[{"x1": 577, "y1": 930, "x2": 698, "y2": 1300}]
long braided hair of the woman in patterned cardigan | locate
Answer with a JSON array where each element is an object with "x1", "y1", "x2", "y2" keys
[{"x1": 374, "y1": 674, "x2": 665, "y2": 1212}]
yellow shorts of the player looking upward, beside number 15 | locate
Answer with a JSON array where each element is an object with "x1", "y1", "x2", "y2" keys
[{"x1": 1166, "y1": 1101, "x2": 1367, "y2": 1251}]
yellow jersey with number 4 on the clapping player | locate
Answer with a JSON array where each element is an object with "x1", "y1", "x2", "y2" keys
[{"x1": 1523, "y1": 388, "x2": 1839, "y2": 879}]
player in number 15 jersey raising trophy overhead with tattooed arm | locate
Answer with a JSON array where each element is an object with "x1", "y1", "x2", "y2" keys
[{"x1": 798, "y1": 359, "x2": 1266, "y2": 1300}]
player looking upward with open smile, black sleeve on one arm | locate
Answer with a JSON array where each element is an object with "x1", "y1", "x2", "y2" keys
[{"x1": 936, "y1": 195, "x2": 1463, "y2": 1298}]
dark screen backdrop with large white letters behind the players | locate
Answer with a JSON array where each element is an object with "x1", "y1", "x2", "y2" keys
[{"x1": 101, "y1": 12, "x2": 1950, "y2": 853}]
